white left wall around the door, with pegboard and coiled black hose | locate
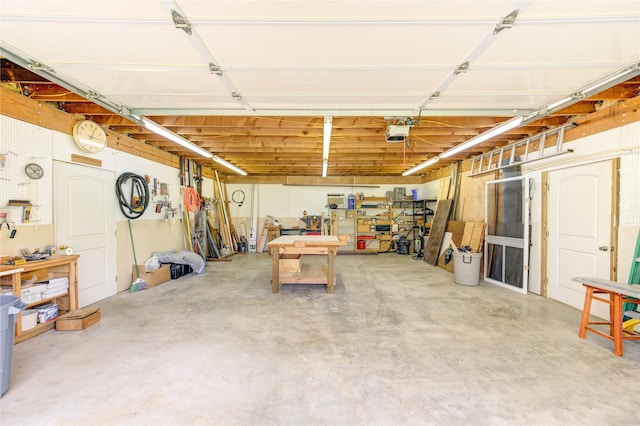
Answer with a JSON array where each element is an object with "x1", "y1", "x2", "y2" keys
[{"x1": 0, "y1": 115, "x2": 188, "y2": 291}]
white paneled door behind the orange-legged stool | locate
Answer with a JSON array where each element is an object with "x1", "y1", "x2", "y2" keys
[{"x1": 547, "y1": 162, "x2": 612, "y2": 318}]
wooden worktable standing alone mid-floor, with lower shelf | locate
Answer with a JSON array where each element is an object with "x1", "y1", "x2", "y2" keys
[{"x1": 267, "y1": 235, "x2": 344, "y2": 293}]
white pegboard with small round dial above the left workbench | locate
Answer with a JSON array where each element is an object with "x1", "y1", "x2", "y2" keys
[{"x1": 0, "y1": 116, "x2": 53, "y2": 225}]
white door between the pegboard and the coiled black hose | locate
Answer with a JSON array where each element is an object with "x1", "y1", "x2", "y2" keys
[{"x1": 53, "y1": 161, "x2": 117, "y2": 307}]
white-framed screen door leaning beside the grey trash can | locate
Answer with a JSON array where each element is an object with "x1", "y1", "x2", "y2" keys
[{"x1": 484, "y1": 176, "x2": 530, "y2": 294}]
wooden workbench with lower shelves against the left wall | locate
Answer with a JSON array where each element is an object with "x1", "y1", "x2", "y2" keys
[{"x1": 0, "y1": 255, "x2": 80, "y2": 343}]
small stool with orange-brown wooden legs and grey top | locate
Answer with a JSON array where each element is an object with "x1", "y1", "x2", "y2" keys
[{"x1": 573, "y1": 277, "x2": 640, "y2": 356}]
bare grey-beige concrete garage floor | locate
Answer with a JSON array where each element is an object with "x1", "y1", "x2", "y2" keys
[{"x1": 0, "y1": 254, "x2": 640, "y2": 426}]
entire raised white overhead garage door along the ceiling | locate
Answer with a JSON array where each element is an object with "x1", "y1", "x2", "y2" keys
[{"x1": 0, "y1": 0, "x2": 640, "y2": 117}]
